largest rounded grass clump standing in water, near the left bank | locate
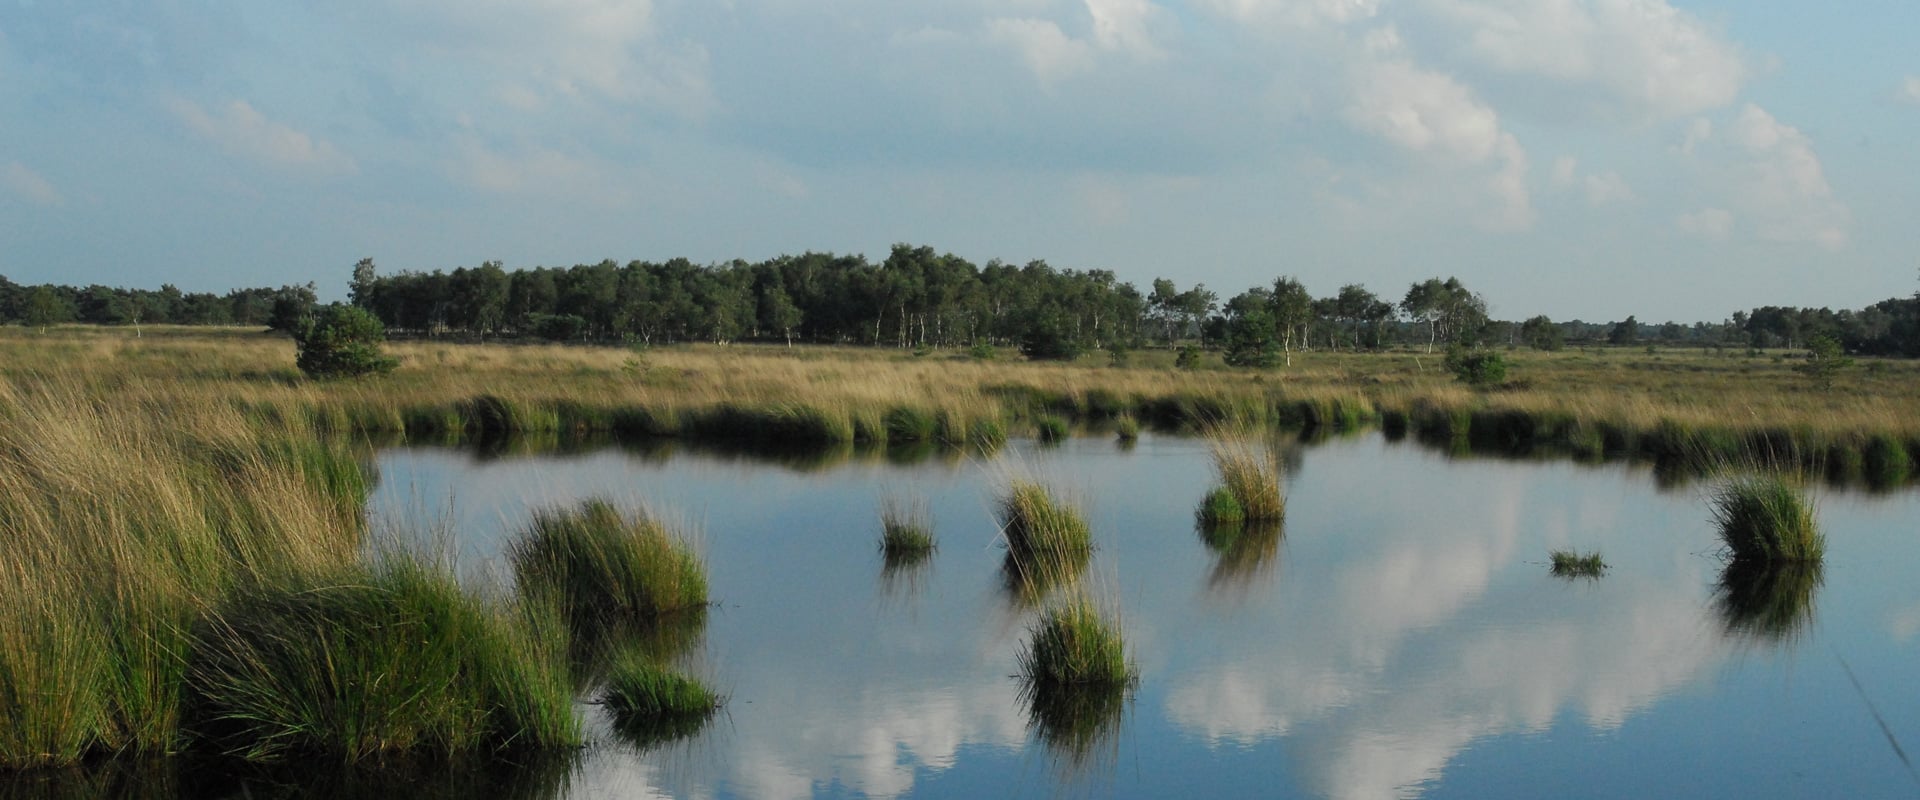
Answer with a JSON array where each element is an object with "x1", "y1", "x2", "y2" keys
[{"x1": 509, "y1": 501, "x2": 707, "y2": 625}]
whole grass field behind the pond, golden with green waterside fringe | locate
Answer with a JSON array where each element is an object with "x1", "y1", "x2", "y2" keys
[{"x1": 0, "y1": 326, "x2": 1920, "y2": 472}]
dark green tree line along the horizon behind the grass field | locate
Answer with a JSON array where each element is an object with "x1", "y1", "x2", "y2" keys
[{"x1": 0, "y1": 244, "x2": 1920, "y2": 356}]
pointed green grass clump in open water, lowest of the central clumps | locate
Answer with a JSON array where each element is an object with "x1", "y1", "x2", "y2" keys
[{"x1": 1020, "y1": 595, "x2": 1139, "y2": 691}]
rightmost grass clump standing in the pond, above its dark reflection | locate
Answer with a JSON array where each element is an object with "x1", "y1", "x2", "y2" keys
[{"x1": 1713, "y1": 474, "x2": 1826, "y2": 564}]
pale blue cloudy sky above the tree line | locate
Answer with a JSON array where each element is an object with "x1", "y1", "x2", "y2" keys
[{"x1": 0, "y1": 0, "x2": 1920, "y2": 322}]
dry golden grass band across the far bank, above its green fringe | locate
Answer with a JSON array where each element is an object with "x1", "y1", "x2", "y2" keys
[{"x1": 0, "y1": 326, "x2": 1920, "y2": 439}]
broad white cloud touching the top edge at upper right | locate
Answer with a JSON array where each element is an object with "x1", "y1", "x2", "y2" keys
[{"x1": 1423, "y1": 0, "x2": 1747, "y2": 119}]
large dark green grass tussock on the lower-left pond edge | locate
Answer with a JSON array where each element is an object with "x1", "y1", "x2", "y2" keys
[{"x1": 188, "y1": 558, "x2": 580, "y2": 762}]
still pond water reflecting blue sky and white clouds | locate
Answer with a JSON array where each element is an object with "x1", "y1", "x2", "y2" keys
[{"x1": 349, "y1": 435, "x2": 1920, "y2": 798}]
